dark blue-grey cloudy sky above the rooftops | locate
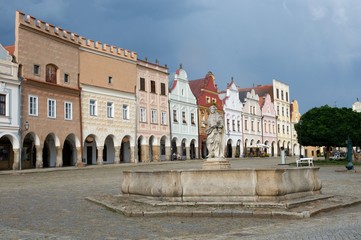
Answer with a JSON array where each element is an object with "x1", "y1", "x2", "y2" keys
[{"x1": 0, "y1": 0, "x2": 361, "y2": 114}]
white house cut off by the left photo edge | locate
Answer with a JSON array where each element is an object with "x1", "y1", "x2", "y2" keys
[{"x1": 0, "y1": 44, "x2": 20, "y2": 170}]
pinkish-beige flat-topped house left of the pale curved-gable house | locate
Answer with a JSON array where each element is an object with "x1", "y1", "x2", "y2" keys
[{"x1": 136, "y1": 59, "x2": 171, "y2": 162}]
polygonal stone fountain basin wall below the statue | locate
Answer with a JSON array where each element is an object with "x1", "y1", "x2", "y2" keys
[{"x1": 121, "y1": 167, "x2": 322, "y2": 202}]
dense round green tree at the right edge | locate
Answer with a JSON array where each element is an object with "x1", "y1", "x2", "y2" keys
[{"x1": 295, "y1": 105, "x2": 361, "y2": 159}]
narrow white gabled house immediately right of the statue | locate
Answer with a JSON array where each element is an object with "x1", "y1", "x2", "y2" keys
[{"x1": 219, "y1": 79, "x2": 243, "y2": 158}]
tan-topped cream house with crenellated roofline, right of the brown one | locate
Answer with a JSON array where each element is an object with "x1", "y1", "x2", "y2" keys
[{"x1": 79, "y1": 38, "x2": 137, "y2": 165}]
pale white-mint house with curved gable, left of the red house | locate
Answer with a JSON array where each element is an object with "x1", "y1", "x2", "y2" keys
[{"x1": 169, "y1": 67, "x2": 198, "y2": 160}]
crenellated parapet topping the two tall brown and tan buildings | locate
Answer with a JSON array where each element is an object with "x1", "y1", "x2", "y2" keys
[{"x1": 16, "y1": 11, "x2": 137, "y2": 61}]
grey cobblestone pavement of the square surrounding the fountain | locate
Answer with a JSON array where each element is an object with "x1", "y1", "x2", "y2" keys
[{"x1": 0, "y1": 158, "x2": 361, "y2": 239}]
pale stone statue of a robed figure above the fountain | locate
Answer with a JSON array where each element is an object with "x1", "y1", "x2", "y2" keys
[{"x1": 204, "y1": 105, "x2": 224, "y2": 158}]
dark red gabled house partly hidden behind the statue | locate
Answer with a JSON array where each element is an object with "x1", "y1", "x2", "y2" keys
[{"x1": 189, "y1": 72, "x2": 224, "y2": 158}]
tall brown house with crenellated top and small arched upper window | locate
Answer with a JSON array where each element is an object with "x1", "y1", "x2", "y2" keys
[{"x1": 14, "y1": 12, "x2": 81, "y2": 168}]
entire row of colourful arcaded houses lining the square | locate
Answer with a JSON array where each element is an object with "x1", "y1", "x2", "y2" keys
[{"x1": 0, "y1": 12, "x2": 301, "y2": 170}]
